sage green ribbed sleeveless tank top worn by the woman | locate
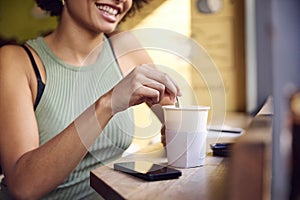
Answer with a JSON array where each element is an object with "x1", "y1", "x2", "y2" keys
[{"x1": 27, "y1": 37, "x2": 134, "y2": 199}]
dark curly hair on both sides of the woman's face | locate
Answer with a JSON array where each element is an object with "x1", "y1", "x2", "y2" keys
[{"x1": 36, "y1": 0, "x2": 149, "y2": 20}]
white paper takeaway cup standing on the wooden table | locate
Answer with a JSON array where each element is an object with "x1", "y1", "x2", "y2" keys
[{"x1": 163, "y1": 106, "x2": 210, "y2": 168}]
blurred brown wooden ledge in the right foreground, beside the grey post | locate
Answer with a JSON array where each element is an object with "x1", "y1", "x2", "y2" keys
[{"x1": 228, "y1": 97, "x2": 273, "y2": 200}]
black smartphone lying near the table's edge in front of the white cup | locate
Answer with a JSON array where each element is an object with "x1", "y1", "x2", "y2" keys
[{"x1": 114, "y1": 161, "x2": 181, "y2": 181}]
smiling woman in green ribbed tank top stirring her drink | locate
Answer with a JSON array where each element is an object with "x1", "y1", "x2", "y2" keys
[{"x1": 0, "y1": 0, "x2": 181, "y2": 199}]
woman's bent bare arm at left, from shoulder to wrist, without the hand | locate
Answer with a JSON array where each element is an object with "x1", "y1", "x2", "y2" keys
[{"x1": 0, "y1": 46, "x2": 111, "y2": 199}]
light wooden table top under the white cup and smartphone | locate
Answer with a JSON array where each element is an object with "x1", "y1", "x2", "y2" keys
[{"x1": 90, "y1": 112, "x2": 248, "y2": 200}]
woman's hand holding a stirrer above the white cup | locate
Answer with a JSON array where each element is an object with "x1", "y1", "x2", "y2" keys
[{"x1": 111, "y1": 64, "x2": 181, "y2": 114}]
